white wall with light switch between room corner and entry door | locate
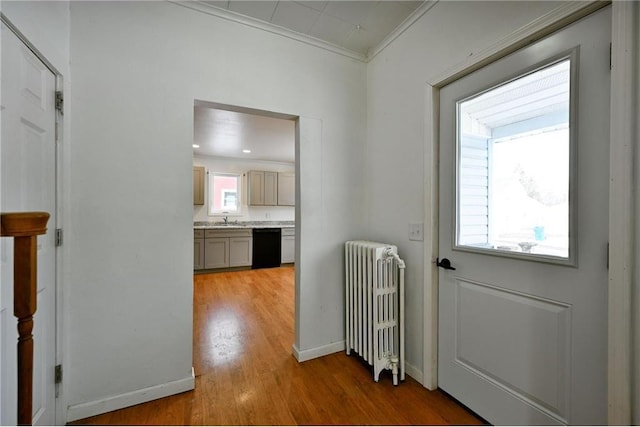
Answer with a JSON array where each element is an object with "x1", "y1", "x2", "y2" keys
[{"x1": 365, "y1": 1, "x2": 558, "y2": 380}]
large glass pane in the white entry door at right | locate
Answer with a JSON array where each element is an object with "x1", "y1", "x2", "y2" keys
[{"x1": 456, "y1": 60, "x2": 570, "y2": 258}]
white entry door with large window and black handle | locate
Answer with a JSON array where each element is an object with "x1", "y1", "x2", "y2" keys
[{"x1": 438, "y1": 8, "x2": 611, "y2": 425}]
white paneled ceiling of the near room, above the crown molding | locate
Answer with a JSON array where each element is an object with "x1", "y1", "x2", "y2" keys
[{"x1": 199, "y1": 0, "x2": 424, "y2": 57}]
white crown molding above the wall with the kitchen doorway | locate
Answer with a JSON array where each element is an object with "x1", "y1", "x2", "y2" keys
[{"x1": 168, "y1": 0, "x2": 367, "y2": 62}]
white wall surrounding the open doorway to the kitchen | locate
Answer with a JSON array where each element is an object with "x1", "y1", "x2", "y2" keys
[{"x1": 68, "y1": 1, "x2": 366, "y2": 418}]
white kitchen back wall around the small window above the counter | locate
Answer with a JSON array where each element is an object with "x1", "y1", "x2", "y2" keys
[{"x1": 193, "y1": 156, "x2": 296, "y2": 221}]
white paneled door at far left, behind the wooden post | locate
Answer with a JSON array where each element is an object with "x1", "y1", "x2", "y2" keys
[{"x1": 0, "y1": 24, "x2": 56, "y2": 425}]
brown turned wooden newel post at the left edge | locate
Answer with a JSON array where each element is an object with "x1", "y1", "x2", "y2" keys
[{"x1": 0, "y1": 212, "x2": 49, "y2": 425}]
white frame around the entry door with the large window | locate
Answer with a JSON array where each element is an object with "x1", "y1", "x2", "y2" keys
[{"x1": 422, "y1": 1, "x2": 640, "y2": 425}]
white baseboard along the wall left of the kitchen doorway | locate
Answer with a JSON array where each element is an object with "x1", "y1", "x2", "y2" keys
[{"x1": 67, "y1": 368, "x2": 195, "y2": 422}]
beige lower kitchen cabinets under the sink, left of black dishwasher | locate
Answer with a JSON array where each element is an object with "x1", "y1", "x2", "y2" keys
[{"x1": 194, "y1": 229, "x2": 253, "y2": 270}]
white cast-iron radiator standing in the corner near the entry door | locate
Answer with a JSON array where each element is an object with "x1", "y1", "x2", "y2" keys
[{"x1": 345, "y1": 240, "x2": 405, "y2": 385}]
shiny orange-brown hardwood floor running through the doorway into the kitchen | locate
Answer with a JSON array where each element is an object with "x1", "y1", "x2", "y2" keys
[{"x1": 75, "y1": 267, "x2": 482, "y2": 425}]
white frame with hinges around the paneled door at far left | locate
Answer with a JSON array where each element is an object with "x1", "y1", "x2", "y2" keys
[{"x1": 0, "y1": 12, "x2": 67, "y2": 425}]
